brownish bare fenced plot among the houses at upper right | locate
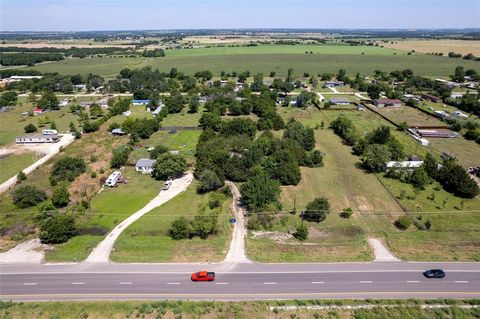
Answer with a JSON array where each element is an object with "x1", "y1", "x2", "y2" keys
[{"x1": 375, "y1": 106, "x2": 447, "y2": 127}]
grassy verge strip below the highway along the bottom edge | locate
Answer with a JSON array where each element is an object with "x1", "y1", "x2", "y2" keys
[{"x1": 0, "y1": 299, "x2": 478, "y2": 319}]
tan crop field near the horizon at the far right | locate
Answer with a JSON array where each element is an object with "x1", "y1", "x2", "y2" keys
[{"x1": 382, "y1": 40, "x2": 480, "y2": 56}]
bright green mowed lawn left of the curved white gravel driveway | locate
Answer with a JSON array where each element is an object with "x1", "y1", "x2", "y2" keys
[{"x1": 45, "y1": 167, "x2": 163, "y2": 261}]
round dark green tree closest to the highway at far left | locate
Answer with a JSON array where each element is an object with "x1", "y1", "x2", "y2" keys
[{"x1": 40, "y1": 214, "x2": 77, "y2": 244}]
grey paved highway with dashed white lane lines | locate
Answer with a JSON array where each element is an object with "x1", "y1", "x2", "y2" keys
[{"x1": 0, "y1": 262, "x2": 480, "y2": 301}]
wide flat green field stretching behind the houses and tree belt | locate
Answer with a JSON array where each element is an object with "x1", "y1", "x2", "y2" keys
[{"x1": 21, "y1": 52, "x2": 480, "y2": 78}]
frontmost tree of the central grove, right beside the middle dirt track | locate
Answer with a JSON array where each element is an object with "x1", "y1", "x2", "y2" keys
[{"x1": 240, "y1": 169, "x2": 280, "y2": 211}]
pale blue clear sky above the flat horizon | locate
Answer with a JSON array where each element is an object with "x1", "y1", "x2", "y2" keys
[{"x1": 0, "y1": 0, "x2": 480, "y2": 31}]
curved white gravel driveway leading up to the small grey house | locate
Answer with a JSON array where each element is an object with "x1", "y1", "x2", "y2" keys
[{"x1": 86, "y1": 173, "x2": 193, "y2": 263}]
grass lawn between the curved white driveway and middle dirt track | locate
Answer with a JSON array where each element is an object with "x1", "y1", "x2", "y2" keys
[{"x1": 111, "y1": 181, "x2": 233, "y2": 262}]
